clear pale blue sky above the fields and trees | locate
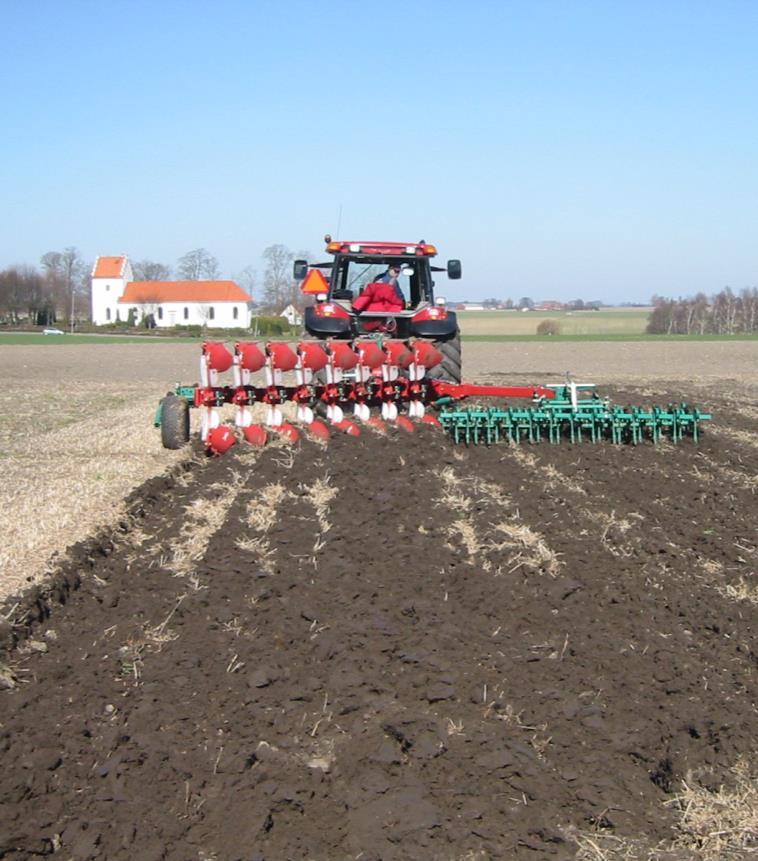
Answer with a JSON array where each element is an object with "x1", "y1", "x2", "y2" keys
[{"x1": 0, "y1": 0, "x2": 758, "y2": 302}]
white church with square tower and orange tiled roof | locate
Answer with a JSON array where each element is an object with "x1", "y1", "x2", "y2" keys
[{"x1": 92, "y1": 256, "x2": 250, "y2": 328}]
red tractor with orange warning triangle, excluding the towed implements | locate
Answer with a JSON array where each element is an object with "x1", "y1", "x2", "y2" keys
[{"x1": 294, "y1": 235, "x2": 461, "y2": 383}]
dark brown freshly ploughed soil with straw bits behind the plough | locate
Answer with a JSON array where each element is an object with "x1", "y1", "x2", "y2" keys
[{"x1": 0, "y1": 384, "x2": 758, "y2": 861}]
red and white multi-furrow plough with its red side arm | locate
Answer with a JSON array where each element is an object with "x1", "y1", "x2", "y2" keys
[{"x1": 193, "y1": 338, "x2": 555, "y2": 454}]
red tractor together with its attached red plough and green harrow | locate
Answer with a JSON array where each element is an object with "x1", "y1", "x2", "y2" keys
[{"x1": 155, "y1": 236, "x2": 710, "y2": 454}]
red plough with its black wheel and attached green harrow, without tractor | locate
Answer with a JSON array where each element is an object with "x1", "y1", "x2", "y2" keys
[{"x1": 155, "y1": 338, "x2": 711, "y2": 454}]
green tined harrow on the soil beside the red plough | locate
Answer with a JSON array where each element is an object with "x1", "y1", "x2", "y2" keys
[{"x1": 438, "y1": 383, "x2": 711, "y2": 445}]
